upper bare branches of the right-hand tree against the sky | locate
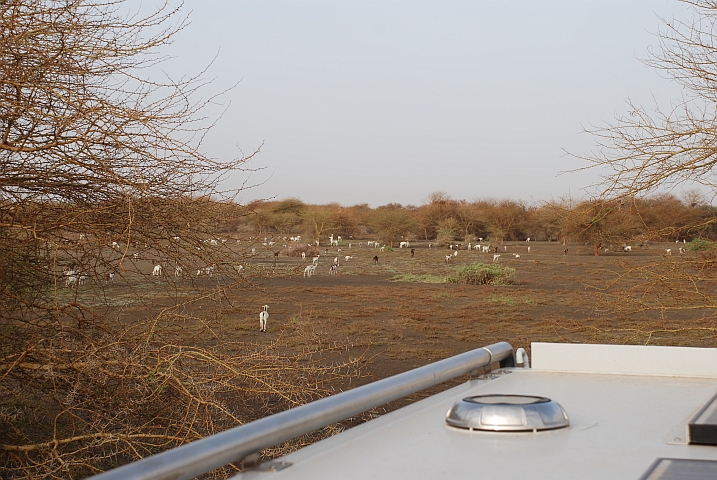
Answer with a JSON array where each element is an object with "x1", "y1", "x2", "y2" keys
[{"x1": 584, "y1": 0, "x2": 717, "y2": 203}]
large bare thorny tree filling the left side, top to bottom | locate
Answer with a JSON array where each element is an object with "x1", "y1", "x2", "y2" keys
[{"x1": 0, "y1": 0, "x2": 360, "y2": 478}]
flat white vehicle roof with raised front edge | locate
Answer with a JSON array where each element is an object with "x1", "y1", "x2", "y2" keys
[{"x1": 236, "y1": 343, "x2": 717, "y2": 480}]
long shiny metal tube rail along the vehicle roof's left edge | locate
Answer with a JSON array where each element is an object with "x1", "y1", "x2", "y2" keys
[{"x1": 92, "y1": 342, "x2": 515, "y2": 480}]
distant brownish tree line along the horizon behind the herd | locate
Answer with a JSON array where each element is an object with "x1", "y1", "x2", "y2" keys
[{"x1": 228, "y1": 192, "x2": 717, "y2": 251}]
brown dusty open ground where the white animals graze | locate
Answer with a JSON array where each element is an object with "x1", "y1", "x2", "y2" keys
[{"x1": 210, "y1": 242, "x2": 717, "y2": 390}]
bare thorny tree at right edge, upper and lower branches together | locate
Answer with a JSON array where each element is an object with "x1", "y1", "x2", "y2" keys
[{"x1": 583, "y1": 0, "x2": 717, "y2": 318}]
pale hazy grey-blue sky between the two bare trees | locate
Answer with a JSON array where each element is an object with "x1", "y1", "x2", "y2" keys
[{"x1": 159, "y1": 0, "x2": 690, "y2": 207}]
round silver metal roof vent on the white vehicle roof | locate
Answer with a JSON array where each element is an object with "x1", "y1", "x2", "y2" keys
[{"x1": 446, "y1": 394, "x2": 570, "y2": 432}]
